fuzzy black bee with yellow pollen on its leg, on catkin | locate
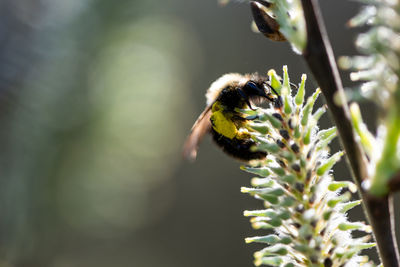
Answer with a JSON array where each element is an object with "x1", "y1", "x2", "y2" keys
[{"x1": 183, "y1": 73, "x2": 282, "y2": 161}]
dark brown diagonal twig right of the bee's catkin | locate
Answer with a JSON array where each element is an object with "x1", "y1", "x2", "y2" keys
[{"x1": 301, "y1": 0, "x2": 400, "y2": 267}]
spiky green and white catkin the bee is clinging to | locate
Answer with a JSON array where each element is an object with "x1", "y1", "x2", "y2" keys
[{"x1": 242, "y1": 68, "x2": 370, "y2": 267}]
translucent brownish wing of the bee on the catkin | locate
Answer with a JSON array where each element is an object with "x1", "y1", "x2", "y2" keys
[{"x1": 183, "y1": 105, "x2": 211, "y2": 161}]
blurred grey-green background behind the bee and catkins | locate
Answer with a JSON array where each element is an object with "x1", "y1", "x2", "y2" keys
[{"x1": 0, "y1": 0, "x2": 396, "y2": 267}]
